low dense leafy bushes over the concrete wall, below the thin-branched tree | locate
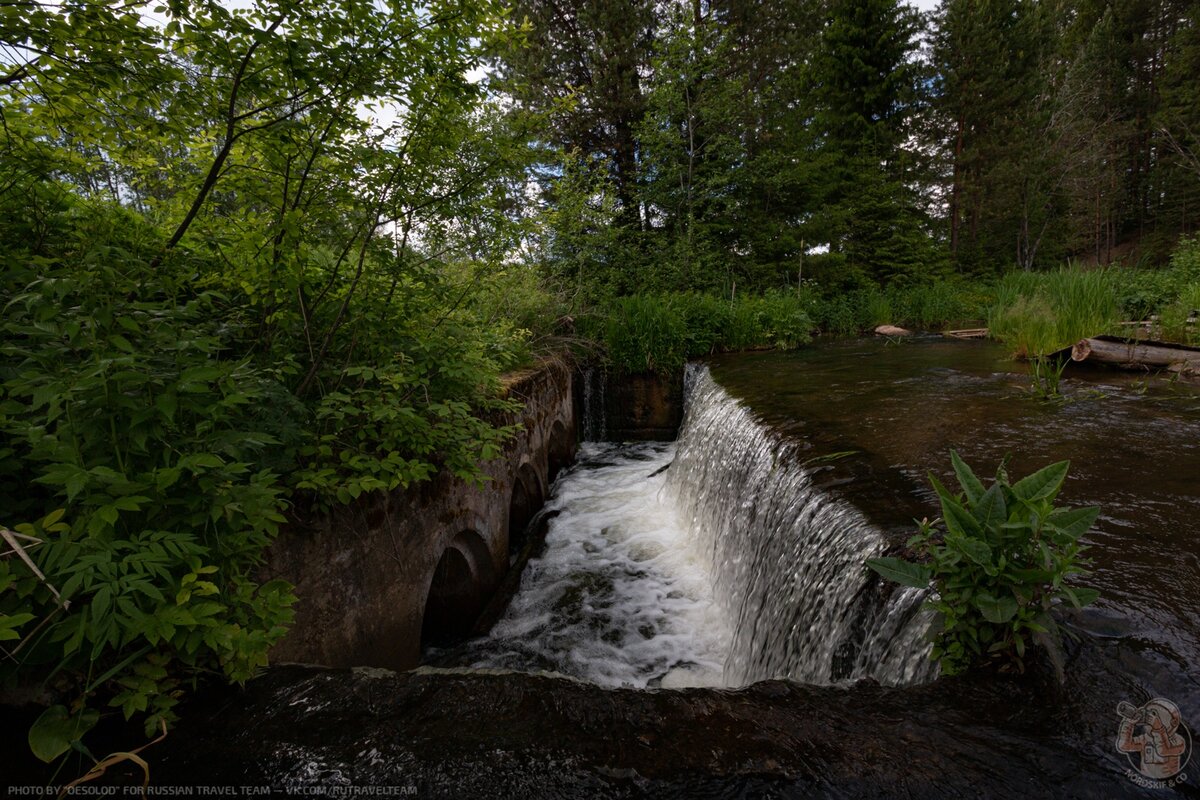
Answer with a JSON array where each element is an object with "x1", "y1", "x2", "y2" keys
[{"x1": 0, "y1": 194, "x2": 530, "y2": 757}]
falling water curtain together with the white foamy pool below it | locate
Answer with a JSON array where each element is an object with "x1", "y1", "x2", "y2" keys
[{"x1": 454, "y1": 366, "x2": 935, "y2": 687}]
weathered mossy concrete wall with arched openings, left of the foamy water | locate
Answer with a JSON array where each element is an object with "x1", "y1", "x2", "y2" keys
[{"x1": 263, "y1": 361, "x2": 576, "y2": 669}]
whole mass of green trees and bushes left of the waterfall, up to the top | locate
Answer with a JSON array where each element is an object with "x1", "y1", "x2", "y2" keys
[{"x1": 0, "y1": 2, "x2": 535, "y2": 763}]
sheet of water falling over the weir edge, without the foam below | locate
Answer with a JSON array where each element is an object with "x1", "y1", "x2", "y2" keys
[{"x1": 665, "y1": 365, "x2": 936, "y2": 686}]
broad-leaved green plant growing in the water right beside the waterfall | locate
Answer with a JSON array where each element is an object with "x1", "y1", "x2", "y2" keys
[{"x1": 866, "y1": 452, "x2": 1100, "y2": 675}]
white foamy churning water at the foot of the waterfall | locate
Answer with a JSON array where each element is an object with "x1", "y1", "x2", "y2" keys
[{"x1": 470, "y1": 443, "x2": 731, "y2": 687}]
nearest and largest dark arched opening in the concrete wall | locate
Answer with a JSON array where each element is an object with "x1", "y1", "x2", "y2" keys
[{"x1": 421, "y1": 530, "x2": 496, "y2": 648}]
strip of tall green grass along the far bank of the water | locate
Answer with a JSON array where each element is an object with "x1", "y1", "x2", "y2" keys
[{"x1": 590, "y1": 239, "x2": 1200, "y2": 372}]
